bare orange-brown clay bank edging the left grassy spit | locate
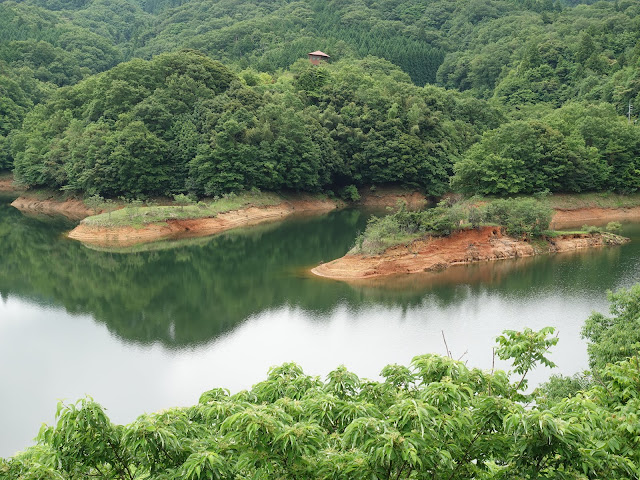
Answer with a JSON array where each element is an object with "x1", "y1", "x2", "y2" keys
[{"x1": 69, "y1": 198, "x2": 338, "y2": 247}]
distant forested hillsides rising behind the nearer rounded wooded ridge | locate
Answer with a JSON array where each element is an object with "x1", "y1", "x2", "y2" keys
[{"x1": 0, "y1": 0, "x2": 640, "y2": 94}]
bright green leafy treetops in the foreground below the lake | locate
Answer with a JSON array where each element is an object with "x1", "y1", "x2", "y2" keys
[{"x1": 0, "y1": 285, "x2": 640, "y2": 480}]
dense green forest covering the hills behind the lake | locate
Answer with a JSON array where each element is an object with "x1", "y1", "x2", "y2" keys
[{"x1": 0, "y1": 0, "x2": 640, "y2": 198}]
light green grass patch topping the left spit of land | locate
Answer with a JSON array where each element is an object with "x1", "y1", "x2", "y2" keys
[{"x1": 82, "y1": 192, "x2": 283, "y2": 228}]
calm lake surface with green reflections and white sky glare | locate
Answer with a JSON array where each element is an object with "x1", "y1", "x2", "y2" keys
[{"x1": 0, "y1": 195, "x2": 640, "y2": 457}]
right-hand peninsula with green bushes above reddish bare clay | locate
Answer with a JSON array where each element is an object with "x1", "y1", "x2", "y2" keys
[{"x1": 311, "y1": 198, "x2": 640, "y2": 280}]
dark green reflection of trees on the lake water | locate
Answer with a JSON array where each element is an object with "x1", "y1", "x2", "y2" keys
[{"x1": 0, "y1": 201, "x2": 638, "y2": 346}]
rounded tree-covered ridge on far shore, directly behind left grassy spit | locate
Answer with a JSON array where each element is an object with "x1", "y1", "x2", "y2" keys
[{"x1": 11, "y1": 50, "x2": 501, "y2": 197}]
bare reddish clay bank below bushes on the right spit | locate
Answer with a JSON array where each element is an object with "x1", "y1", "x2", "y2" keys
[{"x1": 311, "y1": 227, "x2": 626, "y2": 280}]
